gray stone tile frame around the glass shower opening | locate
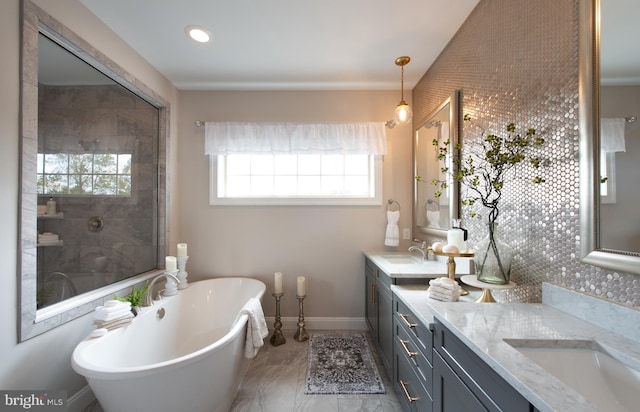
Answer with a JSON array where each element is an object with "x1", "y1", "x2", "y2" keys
[{"x1": 17, "y1": 0, "x2": 169, "y2": 342}]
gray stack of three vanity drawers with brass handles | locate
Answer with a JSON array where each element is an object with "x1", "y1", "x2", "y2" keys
[{"x1": 393, "y1": 299, "x2": 433, "y2": 412}]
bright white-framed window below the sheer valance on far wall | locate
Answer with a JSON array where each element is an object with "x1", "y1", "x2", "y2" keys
[{"x1": 210, "y1": 154, "x2": 381, "y2": 204}]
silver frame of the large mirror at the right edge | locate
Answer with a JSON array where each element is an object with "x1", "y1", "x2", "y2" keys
[{"x1": 578, "y1": 0, "x2": 640, "y2": 273}]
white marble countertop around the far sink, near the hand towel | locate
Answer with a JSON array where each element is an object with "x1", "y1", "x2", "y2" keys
[{"x1": 364, "y1": 252, "x2": 471, "y2": 278}]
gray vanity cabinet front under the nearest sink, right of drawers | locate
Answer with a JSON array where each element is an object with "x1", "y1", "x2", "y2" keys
[{"x1": 433, "y1": 319, "x2": 533, "y2": 412}]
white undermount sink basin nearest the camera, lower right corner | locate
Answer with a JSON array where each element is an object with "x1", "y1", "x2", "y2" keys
[{"x1": 504, "y1": 339, "x2": 640, "y2": 412}]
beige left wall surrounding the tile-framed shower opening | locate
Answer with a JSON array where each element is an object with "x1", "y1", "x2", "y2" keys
[{"x1": 0, "y1": 0, "x2": 177, "y2": 396}]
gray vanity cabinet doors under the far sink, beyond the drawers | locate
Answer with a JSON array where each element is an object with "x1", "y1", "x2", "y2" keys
[{"x1": 365, "y1": 259, "x2": 393, "y2": 372}]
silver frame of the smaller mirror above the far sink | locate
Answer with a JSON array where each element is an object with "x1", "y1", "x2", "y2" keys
[{"x1": 412, "y1": 90, "x2": 460, "y2": 241}]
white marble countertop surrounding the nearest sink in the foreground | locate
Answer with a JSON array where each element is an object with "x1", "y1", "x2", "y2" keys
[{"x1": 391, "y1": 285, "x2": 640, "y2": 412}]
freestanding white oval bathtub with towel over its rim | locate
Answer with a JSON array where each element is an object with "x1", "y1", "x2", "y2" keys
[{"x1": 72, "y1": 278, "x2": 265, "y2": 412}]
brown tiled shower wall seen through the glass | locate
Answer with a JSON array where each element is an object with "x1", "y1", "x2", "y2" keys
[{"x1": 38, "y1": 84, "x2": 158, "y2": 302}]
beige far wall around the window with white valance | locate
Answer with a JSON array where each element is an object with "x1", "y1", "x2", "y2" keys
[{"x1": 174, "y1": 91, "x2": 412, "y2": 318}]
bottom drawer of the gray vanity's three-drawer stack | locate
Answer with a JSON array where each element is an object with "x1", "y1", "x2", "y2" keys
[{"x1": 393, "y1": 342, "x2": 433, "y2": 412}]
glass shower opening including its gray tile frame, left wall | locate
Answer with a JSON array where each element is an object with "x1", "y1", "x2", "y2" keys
[{"x1": 18, "y1": 1, "x2": 167, "y2": 341}]
